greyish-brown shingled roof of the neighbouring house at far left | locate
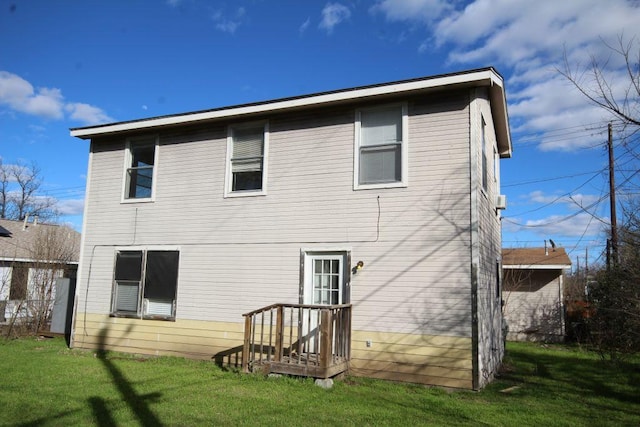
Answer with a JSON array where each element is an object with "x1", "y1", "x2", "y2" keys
[{"x1": 0, "y1": 219, "x2": 80, "y2": 264}]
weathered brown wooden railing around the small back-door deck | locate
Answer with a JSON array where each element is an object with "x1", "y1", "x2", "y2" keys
[{"x1": 242, "y1": 304, "x2": 351, "y2": 378}]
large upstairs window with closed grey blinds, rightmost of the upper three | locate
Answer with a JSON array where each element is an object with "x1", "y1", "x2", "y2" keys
[{"x1": 354, "y1": 104, "x2": 407, "y2": 188}]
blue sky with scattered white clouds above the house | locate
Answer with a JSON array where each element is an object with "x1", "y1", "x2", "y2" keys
[{"x1": 0, "y1": 0, "x2": 640, "y2": 270}]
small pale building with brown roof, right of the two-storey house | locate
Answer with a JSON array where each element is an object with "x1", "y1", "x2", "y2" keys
[{"x1": 502, "y1": 247, "x2": 571, "y2": 341}]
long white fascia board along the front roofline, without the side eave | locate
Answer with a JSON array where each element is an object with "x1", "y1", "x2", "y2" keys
[{"x1": 71, "y1": 69, "x2": 503, "y2": 139}]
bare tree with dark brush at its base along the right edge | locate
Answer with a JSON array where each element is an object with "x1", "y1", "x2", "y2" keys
[{"x1": 558, "y1": 36, "x2": 640, "y2": 360}]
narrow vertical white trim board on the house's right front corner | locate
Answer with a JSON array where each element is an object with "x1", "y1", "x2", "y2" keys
[{"x1": 469, "y1": 89, "x2": 480, "y2": 390}]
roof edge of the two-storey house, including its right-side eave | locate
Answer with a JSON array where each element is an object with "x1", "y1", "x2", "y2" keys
[{"x1": 71, "y1": 67, "x2": 512, "y2": 157}]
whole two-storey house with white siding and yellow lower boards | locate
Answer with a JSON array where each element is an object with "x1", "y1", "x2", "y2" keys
[{"x1": 71, "y1": 68, "x2": 511, "y2": 389}]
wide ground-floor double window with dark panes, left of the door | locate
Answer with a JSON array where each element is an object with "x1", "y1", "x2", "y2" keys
[{"x1": 112, "y1": 250, "x2": 180, "y2": 320}]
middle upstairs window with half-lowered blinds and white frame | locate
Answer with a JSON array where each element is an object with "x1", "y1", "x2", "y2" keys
[{"x1": 225, "y1": 122, "x2": 269, "y2": 195}]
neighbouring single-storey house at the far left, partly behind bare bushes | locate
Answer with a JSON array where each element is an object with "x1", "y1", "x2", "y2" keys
[{"x1": 0, "y1": 216, "x2": 80, "y2": 322}]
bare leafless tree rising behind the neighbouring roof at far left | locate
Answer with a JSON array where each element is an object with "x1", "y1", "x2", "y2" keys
[{"x1": 0, "y1": 161, "x2": 57, "y2": 220}]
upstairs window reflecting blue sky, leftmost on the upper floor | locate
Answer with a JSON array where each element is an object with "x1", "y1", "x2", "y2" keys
[{"x1": 124, "y1": 137, "x2": 158, "y2": 200}]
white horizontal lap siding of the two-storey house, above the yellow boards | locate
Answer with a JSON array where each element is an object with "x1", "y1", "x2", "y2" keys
[{"x1": 75, "y1": 92, "x2": 500, "y2": 387}]
